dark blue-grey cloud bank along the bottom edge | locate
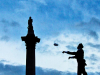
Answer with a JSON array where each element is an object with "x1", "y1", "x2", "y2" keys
[{"x1": 0, "y1": 63, "x2": 100, "y2": 75}]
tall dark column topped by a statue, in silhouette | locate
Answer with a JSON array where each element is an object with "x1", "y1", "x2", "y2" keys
[{"x1": 21, "y1": 17, "x2": 40, "y2": 75}]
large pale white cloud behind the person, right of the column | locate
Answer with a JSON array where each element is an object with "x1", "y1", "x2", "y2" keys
[{"x1": 36, "y1": 32, "x2": 100, "y2": 72}]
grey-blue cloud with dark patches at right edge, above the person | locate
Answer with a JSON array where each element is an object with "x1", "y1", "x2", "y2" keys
[{"x1": 75, "y1": 17, "x2": 100, "y2": 40}]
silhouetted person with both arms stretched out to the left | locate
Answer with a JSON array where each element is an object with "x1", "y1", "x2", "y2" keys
[{"x1": 62, "y1": 43, "x2": 87, "y2": 75}]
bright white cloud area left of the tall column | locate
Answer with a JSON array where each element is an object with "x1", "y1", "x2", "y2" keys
[{"x1": 0, "y1": 40, "x2": 26, "y2": 65}]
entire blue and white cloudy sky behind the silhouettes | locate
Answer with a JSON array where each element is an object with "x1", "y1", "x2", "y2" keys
[{"x1": 0, "y1": 0, "x2": 100, "y2": 75}]
